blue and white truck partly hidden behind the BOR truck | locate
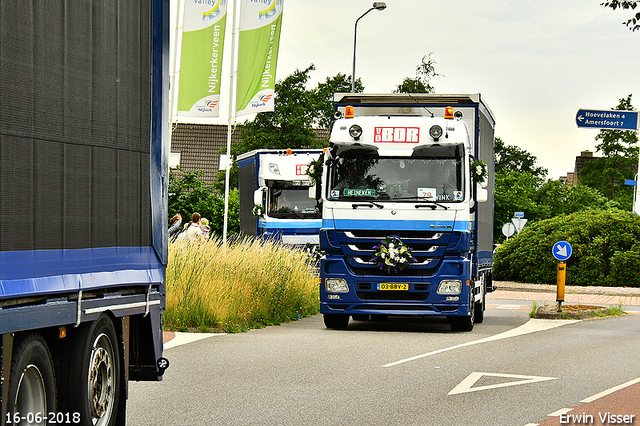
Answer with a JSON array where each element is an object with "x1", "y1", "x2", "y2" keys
[{"x1": 237, "y1": 149, "x2": 322, "y2": 246}]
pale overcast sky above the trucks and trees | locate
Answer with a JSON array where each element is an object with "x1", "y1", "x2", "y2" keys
[{"x1": 172, "y1": 0, "x2": 640, "y2": 179}]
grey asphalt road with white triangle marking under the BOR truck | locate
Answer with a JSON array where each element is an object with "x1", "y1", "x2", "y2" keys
[{"x1": 127, "y1": 300, "x2": 640, "y2": 426}]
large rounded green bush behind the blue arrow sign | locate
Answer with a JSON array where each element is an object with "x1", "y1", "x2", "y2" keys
[{"x1": 494, "y1": 209, "x2": 640, "y2": 287}]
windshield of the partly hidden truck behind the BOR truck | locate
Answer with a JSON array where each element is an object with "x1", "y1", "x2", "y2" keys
[{"x1": 267, "y1": 186, "x2": 321, "y2": 219}]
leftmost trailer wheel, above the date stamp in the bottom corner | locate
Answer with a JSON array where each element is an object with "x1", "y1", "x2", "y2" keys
[{"x1": 7, "y1": 333, "x2": 57, "y2": 425}]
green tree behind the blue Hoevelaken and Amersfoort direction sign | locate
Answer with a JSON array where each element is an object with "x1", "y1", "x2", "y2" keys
[{"x1": 578, "y1": 95, "x2": 638, "y2": 210}]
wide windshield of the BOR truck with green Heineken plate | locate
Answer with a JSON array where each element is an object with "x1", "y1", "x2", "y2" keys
[{"x1": 327, "y1": 154, "x2": 464, "y2": 202}]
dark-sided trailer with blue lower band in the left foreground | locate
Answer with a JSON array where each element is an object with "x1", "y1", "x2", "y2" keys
[{"x1": 0, "y1": 0, "x2": 169, "y2": 426}]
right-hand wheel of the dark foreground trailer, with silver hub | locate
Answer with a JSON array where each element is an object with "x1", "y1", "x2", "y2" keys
[{"x1": 69, "y1": 315, "x2": 121, "y2": 426}]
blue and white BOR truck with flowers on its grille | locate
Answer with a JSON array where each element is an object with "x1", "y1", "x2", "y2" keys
[{"x1": 320, "y1": 94, "x2": 495, "y2": 331}]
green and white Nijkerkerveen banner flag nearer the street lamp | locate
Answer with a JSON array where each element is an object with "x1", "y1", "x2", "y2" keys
[{"x1": 236, "y1": 0, "x2": 284, "y2": 115}]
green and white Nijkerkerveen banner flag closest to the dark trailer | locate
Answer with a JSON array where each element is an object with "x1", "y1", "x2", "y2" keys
[{"x1": 176, "y1": 0, "x2": 228, "y2": 124}]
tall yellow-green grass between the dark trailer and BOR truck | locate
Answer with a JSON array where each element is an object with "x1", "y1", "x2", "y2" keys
[{"x1": 164, "y1": 239, "x2": 320, "y2": 332}]
